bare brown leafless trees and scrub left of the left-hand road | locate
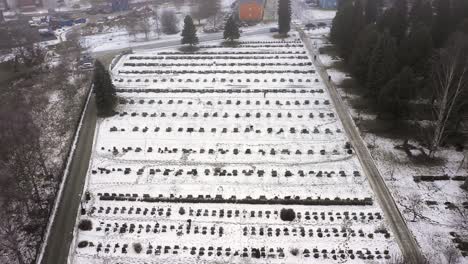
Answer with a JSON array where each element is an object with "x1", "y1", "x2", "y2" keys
[{"x1": 0, "y1": 37, "x2": 90, "y2": 264}]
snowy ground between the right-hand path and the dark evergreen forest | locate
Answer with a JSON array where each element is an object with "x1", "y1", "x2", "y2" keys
[{"x1": 310, "y1": 27, "x2": 468, "y2": 263}]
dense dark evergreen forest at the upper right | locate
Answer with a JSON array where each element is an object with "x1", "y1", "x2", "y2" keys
[{"x1": 330, "y1": 0, "x2": 468, "y2": 155}]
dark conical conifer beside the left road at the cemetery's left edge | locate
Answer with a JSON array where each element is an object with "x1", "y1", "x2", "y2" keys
[{"x1": 93, "y1": 60, "x2": 116, "y2": 117}]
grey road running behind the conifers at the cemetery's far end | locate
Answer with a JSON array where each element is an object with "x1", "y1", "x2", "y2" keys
[{"x1": 92, "y1": 27, "x2": 270, "y2": 57}]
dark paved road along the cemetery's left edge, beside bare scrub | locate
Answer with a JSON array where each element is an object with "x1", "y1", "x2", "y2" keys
[{"x1": 41, "y1": 95, "x2": 97, "y2": 264}]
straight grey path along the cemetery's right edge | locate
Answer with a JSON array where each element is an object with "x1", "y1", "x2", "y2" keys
[{"x1": 298, "y1": 29, "x2": 424, "y2": 264}]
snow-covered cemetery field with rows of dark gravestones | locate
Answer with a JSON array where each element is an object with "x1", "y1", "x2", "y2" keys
[{"x1": 70, "y1": 34, "x2": 399, "y2": 264}]
